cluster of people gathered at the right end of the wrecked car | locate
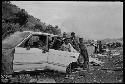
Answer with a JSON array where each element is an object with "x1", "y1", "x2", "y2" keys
[{"x1": 54, "y1": 32, "x2": 89, "y2": 69}]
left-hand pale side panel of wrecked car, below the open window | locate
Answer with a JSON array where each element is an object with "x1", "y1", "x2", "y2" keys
[{"x1": 13, "y1": 36, "x2": 48, "y2": 71}]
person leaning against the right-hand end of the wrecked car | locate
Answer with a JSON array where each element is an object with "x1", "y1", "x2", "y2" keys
[{"x1": 78, "y1": 38, "x2": 89, "y2": 69}]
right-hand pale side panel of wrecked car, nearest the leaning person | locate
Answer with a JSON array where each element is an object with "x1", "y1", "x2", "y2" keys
[{"x1": 48, "y1": 49, "x2": 79, "y2": 73}]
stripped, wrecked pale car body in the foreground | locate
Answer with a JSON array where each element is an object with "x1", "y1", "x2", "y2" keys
[{"x1": 2, "y1": 31, "x2": 80, "y2": 73}]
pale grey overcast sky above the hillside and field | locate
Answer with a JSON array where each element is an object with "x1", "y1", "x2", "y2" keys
[{"x1": 11, "y1": 1, "x2": 123, "y2": 39}]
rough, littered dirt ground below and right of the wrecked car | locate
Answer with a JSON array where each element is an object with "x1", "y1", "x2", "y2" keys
[{"x1": 2, "y1": 47, "x2": 123, "y2": 83}]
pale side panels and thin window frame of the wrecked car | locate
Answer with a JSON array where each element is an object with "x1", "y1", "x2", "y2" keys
[{"x1": 13, "y1": 31, "x2": 79, "y2": 73}]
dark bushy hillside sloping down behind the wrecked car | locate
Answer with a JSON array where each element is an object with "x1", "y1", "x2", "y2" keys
[{"x1": 2, "y1": 1, "x2": 61, "y2": 39}]
